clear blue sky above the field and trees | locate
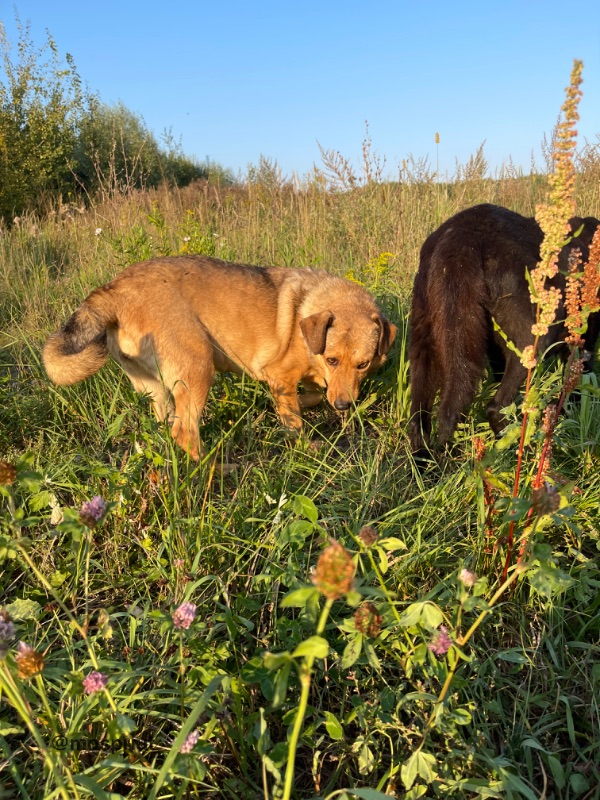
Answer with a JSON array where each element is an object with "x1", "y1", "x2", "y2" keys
[{"x1": 0, "y1": 0, "x2": 600, "y2": 181}]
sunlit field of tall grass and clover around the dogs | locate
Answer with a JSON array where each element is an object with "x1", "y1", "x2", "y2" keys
[{"x1": 0, "y1": 148, "x2": 600, "y2": 800}]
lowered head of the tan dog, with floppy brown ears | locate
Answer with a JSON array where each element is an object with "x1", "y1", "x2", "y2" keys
[{"x1": 300, "y1": 311, "x2": 397, "y2": 411}]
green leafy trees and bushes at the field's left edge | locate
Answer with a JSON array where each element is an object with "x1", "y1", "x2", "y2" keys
[{"x1": 0, "y1": 18, "x2": 232, "y2": 221}]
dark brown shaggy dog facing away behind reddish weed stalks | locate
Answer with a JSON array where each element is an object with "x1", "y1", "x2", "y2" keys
[{"x1": 409, "y1": 204, "x2": 600, "y2": 455}]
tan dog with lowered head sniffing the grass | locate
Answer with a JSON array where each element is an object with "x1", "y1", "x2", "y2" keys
[{"x1": 43, "y1": 256, "x2": 396, "y2": 459}]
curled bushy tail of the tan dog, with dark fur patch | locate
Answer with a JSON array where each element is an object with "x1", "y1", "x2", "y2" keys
[{"x1": 42, "y1": 287, "x2": 117, "y2": 386}]
